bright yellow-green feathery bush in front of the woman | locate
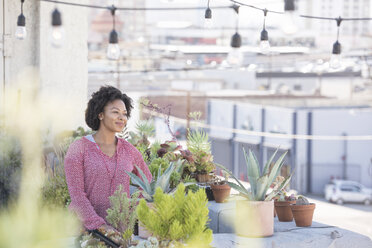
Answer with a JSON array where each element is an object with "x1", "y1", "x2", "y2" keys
[{"x1": 137, "y1": 183, "x2": 212, "y2": 247}]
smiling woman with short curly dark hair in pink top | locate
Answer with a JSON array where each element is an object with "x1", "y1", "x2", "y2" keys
[{"x1": 65, "y1": 86, "x2": 151, "y2": 230}]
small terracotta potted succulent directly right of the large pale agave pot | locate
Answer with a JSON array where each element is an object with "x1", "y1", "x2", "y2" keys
[{"x1": 274, "y1": 192, "x2": 296, "y2": 222}]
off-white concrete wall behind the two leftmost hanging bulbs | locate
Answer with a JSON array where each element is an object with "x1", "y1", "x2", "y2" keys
[{"x1": 0, "y1": 0, "x2": 88, "y2": 133}]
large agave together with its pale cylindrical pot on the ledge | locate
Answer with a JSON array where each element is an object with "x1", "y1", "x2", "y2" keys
[{"x1": 217, "y1": 149, "x2": 291, "y2": 237}]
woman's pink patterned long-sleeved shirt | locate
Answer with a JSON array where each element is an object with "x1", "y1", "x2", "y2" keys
[{"x1": 65, "y1": 137, "x2": 152, "y2": 230}]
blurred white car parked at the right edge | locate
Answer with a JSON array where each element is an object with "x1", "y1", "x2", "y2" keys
[{"x1": 324, "y1": 180, "x2": 372, "y2": 205}]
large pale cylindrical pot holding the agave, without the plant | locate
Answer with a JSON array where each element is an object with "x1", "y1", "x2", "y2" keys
[{"x1": 235, "y1": 201, "x2": 274, "y2": 237}]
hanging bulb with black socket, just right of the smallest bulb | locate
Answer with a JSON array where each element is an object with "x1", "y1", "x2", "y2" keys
[{"x1": 227, "y1": 5, "x2": 244, "y2": 67}]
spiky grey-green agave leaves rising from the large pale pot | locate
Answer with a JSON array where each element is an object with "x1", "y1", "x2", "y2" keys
[{"x1": 216, "y1": 149, "x2": 292, "y2": 201}]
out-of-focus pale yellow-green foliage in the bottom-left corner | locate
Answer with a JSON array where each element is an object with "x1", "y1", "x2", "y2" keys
[{"x1": 0, "y1": 203, "x2": 79, "y2": 248}]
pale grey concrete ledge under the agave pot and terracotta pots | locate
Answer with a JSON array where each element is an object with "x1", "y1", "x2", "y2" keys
[{"x1": 208, "y1": 201, "x2": 372, "y2": 248}]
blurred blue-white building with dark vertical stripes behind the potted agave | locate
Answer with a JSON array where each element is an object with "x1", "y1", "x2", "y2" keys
[{"x1": 207, "y1": 97, "x2": 372, "y2": 194}]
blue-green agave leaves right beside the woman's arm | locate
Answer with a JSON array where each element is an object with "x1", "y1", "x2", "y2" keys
[{"x1": 126, "y1": 160, "x2": 195, "y2": 202}]
